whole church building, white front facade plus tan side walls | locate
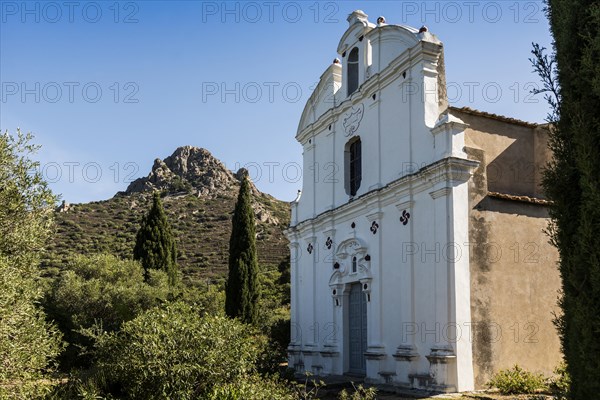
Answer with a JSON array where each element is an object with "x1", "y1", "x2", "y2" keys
[{"x1": 286, "y1": 11, "x2": 560, "y2": 392}]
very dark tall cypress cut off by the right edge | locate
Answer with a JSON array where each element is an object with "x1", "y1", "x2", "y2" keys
[{"x1": 534, "y1": 0, "x2": 600, "y2": 400}]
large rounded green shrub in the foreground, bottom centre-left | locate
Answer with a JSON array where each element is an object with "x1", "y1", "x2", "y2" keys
[{"x1": 90, "y1": 303, "x2": 265, "y2": 400}]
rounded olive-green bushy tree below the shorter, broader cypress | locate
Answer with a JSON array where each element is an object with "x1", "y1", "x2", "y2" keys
[{"x1": 44, "y1": 254, "x2": 169, "y2": 371}]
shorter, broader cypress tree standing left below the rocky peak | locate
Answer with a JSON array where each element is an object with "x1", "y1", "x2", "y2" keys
[{"x1": 133, "y1": 192, "x2": 177, "y2": 286}]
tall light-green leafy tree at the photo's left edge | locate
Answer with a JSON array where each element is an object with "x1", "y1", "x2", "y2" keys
[{"x1": 0, "y1": 132, "x2": 62, "y2": 398}]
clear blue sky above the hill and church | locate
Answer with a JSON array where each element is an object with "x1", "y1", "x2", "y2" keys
[{"x1": 0, "y1": 1, "x2": 551, "y2": 203}]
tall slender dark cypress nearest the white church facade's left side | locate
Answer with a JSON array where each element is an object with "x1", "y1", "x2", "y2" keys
[{"x1": 225, "y1": 172, "x2": 259, "y2": 323}]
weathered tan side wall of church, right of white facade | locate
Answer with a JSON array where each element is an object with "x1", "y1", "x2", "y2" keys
[{"x1": 460, "y1": 109, "x2": 561, "y2": 388}]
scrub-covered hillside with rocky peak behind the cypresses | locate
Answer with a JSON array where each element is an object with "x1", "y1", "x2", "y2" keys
[{"x1": 44, "y1": 146, "x2": 289, "y2": 283}]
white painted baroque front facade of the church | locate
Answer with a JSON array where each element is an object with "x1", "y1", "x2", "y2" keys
[{"x1": 287, "y1": 11, "x2": 477, "y2": 391}]
